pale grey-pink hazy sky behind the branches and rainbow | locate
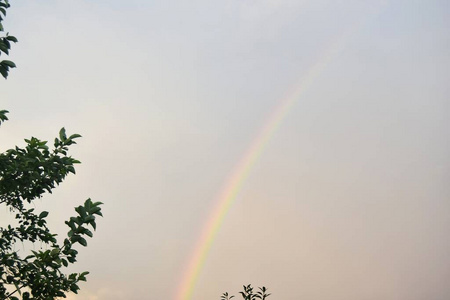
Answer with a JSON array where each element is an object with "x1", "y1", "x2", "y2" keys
[{"x1": 0, "y1": 0, "x2": 450, "y2": 300}]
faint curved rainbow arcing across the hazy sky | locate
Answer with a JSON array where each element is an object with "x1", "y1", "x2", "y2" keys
[{"x1": 175, "y1": 1, "x2": 386, "y2": 300}]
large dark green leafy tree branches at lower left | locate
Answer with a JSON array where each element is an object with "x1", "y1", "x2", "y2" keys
[{"x1": 0, "y1": 110, "x2": 102, "y2": 300}]
